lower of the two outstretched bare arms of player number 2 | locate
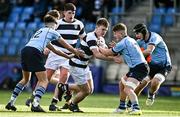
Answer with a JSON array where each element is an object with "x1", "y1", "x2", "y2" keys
[{"x1": 46, "y1": 43, "x2": 73, "y2": 59}]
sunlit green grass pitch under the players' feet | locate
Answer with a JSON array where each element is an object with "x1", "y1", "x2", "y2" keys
[{"x1": 0, "y1": 91, "x2": 180, "y2": 117}]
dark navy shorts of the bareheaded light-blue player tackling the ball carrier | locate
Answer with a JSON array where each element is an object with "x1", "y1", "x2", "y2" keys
[{"x1": 126, "y1": 63, "x2": 149, "y2": 81}]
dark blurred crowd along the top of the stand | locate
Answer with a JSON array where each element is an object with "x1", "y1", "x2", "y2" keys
[{"x1": 0, "y1": 0, "x2": 129, "y2": 22}]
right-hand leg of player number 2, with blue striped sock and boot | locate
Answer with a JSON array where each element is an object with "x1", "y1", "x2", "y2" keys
[{"x1": 31, "y1": 71, "x2": 48, "y2": 112}]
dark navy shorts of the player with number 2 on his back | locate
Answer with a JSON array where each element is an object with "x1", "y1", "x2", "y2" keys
[{"x1": 21, "y1": 46, "x2": 46, "y2": 72}]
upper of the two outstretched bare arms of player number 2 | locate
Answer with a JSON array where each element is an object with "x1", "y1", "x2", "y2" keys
[{"x1": 58, "y1": 38, "x2": 83, "y2": 57}]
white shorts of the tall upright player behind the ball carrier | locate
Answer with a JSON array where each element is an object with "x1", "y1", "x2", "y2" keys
[{"x1": 45, "y1": 52, "x2": 70, "y2": 70}]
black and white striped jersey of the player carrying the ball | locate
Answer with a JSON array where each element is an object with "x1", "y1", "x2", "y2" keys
[{"x1": 69, "y1": 32, "x2": 105, "y2": 68}]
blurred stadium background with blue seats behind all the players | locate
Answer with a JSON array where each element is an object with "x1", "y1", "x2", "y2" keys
[{"x1": 0, "y1": 0, "x2": 180, "y2": 96}]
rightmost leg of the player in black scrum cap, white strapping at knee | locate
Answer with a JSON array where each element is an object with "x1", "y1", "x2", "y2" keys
[{"x1": 146, "y1": 73, "x2": 165, "y2": 106}]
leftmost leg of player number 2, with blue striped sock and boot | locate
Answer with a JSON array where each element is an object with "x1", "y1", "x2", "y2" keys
[{"x1": 5, "y1": 70, "x2": 31, "y2": 111}]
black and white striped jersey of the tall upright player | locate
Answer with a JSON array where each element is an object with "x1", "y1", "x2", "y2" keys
[{"x1": 52, "y1": 19, "x2": 86, "y2": 53}]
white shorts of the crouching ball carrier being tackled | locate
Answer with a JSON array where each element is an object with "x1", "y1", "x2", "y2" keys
[{"x1": 69, "y1": 66, "x2": 92, "y2": 85}]
